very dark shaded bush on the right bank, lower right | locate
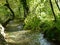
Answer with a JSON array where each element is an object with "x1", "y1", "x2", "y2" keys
[{"x1": 45, "y1": 20, "x2": 60, "y2": 41}]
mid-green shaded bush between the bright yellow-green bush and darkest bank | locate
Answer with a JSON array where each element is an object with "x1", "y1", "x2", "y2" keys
[{"x1": 40, "y1": 20, "x2": 54, "y2": 33}]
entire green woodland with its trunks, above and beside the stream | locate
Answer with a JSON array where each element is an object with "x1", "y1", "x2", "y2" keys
[{"x1": 0, "y1": 0, "x2": 60, "y2": 42}]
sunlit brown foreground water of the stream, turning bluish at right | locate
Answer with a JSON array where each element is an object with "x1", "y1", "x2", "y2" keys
[{"x1": 6, "y1": 21, "x2": 53, "y2": 45}]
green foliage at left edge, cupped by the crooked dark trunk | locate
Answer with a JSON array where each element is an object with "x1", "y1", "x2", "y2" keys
[{"x1": 0, "y1": 6, "x2": 10, "y2": 23}]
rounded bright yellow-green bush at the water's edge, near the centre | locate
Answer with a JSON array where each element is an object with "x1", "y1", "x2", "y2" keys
[{"x1": 24, "y1": 15, "x2": 40, "y2": 30}]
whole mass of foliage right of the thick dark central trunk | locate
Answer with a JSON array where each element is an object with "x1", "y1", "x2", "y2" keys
[{"x1": 24, "y1": 0, "x2": 60, "y2": 41}]
